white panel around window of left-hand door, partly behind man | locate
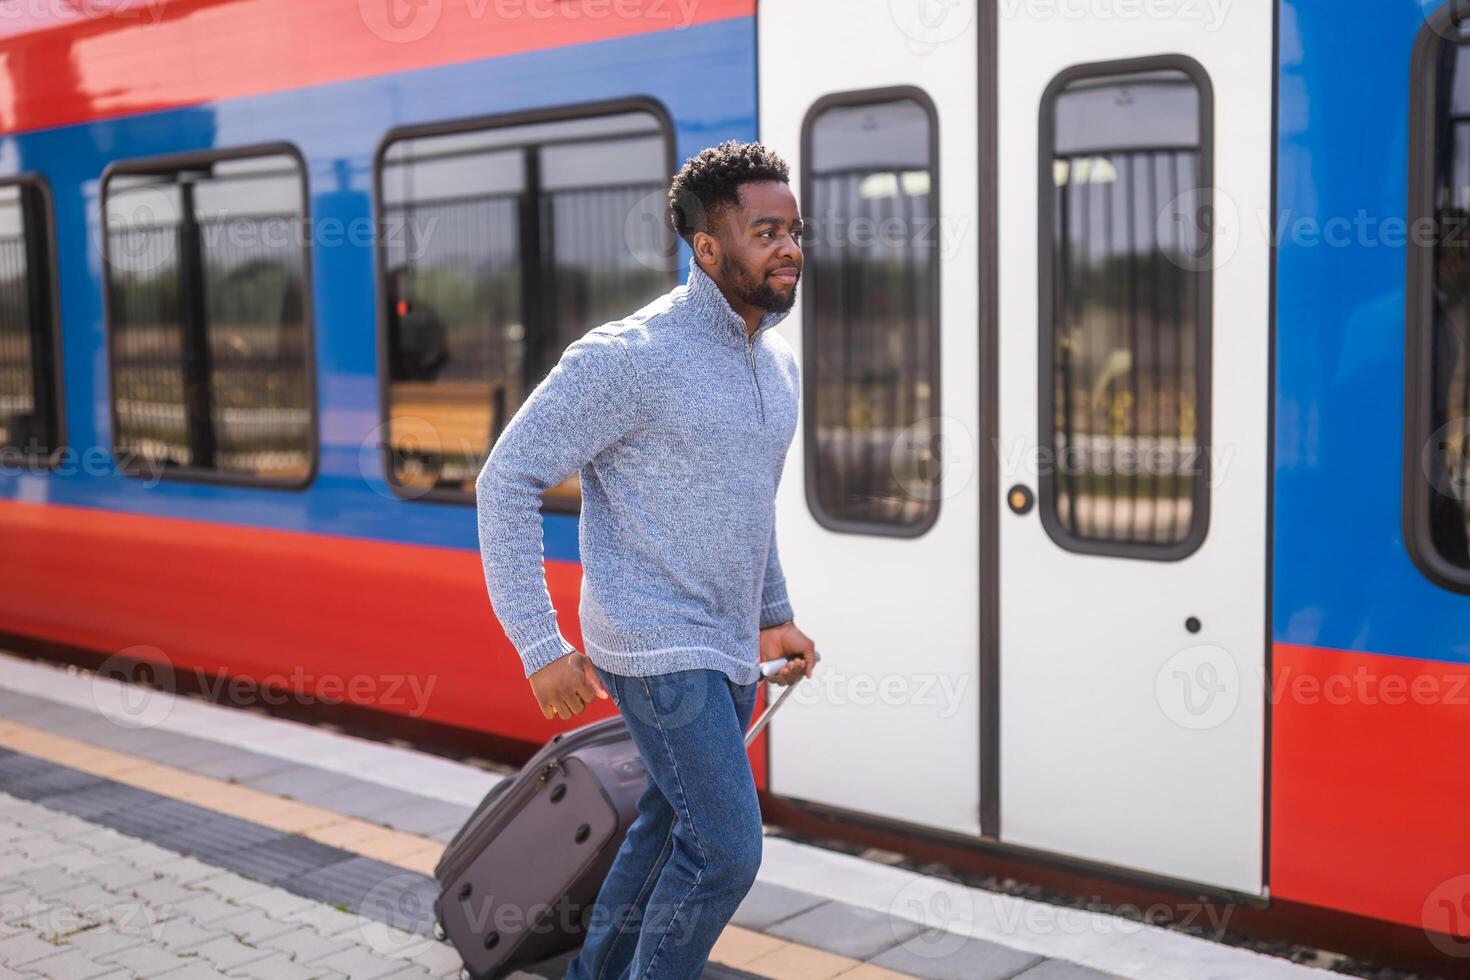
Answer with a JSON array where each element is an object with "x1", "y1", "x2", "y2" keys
[{"x1": 759, "y1": 0, "x2": 980, "y2": 835}]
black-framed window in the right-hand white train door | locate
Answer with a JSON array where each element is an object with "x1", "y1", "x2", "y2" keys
[{"x1": 1039, "y1": 59, "x2": 1211, "y2": 558}]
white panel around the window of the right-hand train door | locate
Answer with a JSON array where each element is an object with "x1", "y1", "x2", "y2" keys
[{"x1": 998, "y1": 11, "x2": 1272, "y2": 893}]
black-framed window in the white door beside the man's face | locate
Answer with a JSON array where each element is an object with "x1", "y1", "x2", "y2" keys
[{"x1": 803, "y1": 88, "x2": 942, "y2": 535}]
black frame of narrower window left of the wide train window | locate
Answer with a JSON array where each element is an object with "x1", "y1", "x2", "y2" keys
[{"x1": 97, "y1": 141, "x2": 322, "y2": 491}]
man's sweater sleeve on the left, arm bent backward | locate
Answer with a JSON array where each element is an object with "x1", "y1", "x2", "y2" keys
[{"x1": 475, "y1": 332, "x2": 639, "y2": 677}]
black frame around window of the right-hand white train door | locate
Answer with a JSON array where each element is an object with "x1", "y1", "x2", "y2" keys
[{"x1": 1036, "y1": 54, "x2": 1214, "y2": 561}]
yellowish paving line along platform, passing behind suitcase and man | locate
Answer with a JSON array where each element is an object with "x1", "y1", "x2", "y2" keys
[{"x1": 0, "y1": 718, "x2": 908, "y2": 980}]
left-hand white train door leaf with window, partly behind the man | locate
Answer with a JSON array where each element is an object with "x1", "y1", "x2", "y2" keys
[{"x1": 757, "y1": 0, "x2": 983, "y2": 835}]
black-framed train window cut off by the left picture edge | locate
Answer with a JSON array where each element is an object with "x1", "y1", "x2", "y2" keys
[{"x1": 0, "y1": 176, "x2": 62, "y2": 466}]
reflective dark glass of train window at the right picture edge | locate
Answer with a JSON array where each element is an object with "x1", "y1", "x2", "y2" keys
[{"x1": 1405, "y1": 26, "x2": 1470, "y2": 585}]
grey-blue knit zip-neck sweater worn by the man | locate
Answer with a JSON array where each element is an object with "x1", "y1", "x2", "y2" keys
[{"x1": 475, "y1": 259, "x2": 798, "y2": 683}]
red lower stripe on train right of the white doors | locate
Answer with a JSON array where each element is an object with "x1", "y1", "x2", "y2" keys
[{"x1": 1270, "y1": 644, "x2": 1470, "y2": 942}]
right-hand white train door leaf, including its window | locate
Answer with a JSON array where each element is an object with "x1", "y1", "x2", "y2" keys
[{"x1": 997, "y1": 9, "x2": 1273, "y2": 893}]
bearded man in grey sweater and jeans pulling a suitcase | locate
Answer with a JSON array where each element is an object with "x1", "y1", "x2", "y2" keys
[{"x1": 476, "y1": 143, "x2": 814, "y2": 980}]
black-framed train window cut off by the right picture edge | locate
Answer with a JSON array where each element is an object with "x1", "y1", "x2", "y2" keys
[{"x1": 1404, "y1": 15, "x2": 1470, "y2": 591}]
